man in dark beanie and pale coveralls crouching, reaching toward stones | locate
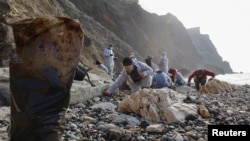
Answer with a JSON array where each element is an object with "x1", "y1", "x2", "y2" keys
[{"x1": 103, "y1": 57, "x2": 153, "y2": 96}]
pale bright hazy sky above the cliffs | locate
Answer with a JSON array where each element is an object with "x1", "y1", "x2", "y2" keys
[{"x1": 139, "y1": 0, "x2": 250, "y2": 73}]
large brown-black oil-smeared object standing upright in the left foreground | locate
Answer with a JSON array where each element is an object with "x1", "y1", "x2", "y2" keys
[{"x1": 9, "y1": 17, "x2": 83, "y2": 141}]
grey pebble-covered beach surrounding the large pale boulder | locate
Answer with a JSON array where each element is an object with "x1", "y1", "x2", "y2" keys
[{"x1": 0, "y1": 85, "x2": 250, "y2": 141}]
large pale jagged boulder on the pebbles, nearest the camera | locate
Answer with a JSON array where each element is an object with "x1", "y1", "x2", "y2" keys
[{"x1": 117, "y1": 88, "x2": 197, "y2": 122}]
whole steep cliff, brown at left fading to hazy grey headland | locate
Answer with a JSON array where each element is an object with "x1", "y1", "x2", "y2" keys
[{"x1": 0, "y1": 0, "x2": 232, "y2": 73}]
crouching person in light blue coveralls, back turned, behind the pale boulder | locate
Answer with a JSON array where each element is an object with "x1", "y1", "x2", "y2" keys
[{"x1": 152, "y1": 70, "x2": 172, "y2": 88}]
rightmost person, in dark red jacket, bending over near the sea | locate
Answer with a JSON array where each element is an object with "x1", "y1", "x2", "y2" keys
[{"x1": 187, "y1": 69, "x2": 215, "y2": 91}]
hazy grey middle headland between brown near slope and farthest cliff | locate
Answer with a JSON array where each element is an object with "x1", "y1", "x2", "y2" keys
[{"x1": 68, "y1": 0, "x2": 200, "y2": 70}]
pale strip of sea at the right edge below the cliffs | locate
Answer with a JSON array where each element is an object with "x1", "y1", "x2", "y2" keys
[{"x1": 215, "y1": 73, "x2": 250, "y2": 85}]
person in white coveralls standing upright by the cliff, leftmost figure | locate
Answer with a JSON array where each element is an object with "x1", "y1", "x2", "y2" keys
[{"x1": 103, "y1": 44, "x2": 114, "y2": 80}]
